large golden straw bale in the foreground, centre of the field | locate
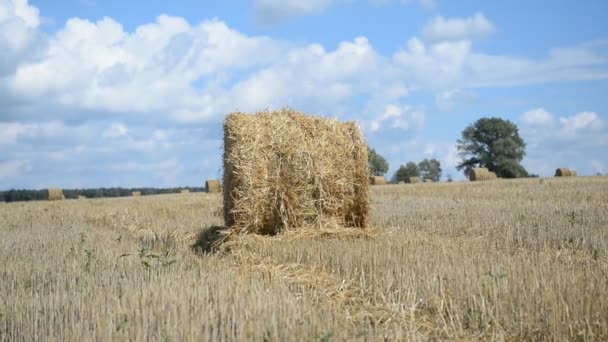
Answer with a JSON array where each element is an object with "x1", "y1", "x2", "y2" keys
[{"x1": 224, "y1": 109, "x2": 369, "y2": 234}]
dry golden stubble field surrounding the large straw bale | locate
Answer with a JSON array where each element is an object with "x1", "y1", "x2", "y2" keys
[{"x1": 0, "y1": 177, "x2": 608, "y2": 341}]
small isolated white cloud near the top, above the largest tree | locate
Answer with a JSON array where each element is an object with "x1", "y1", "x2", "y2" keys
[{"x1": 422, "y1": 12, "x2": 494, "y2": 41}]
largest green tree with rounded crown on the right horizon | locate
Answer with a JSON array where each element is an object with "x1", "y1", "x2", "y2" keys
[{"x1": 456, "y1": 118, "x2": 528, "y2": 178}]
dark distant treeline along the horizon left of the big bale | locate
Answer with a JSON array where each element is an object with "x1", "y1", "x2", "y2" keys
[{"x1": 0, "y1": 187, "x2": 205, "y2": 202}]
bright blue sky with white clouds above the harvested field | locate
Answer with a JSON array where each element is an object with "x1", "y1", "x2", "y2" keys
[{"x1": 0, "y1": 0, "x2": 608, "y2": 190}]
